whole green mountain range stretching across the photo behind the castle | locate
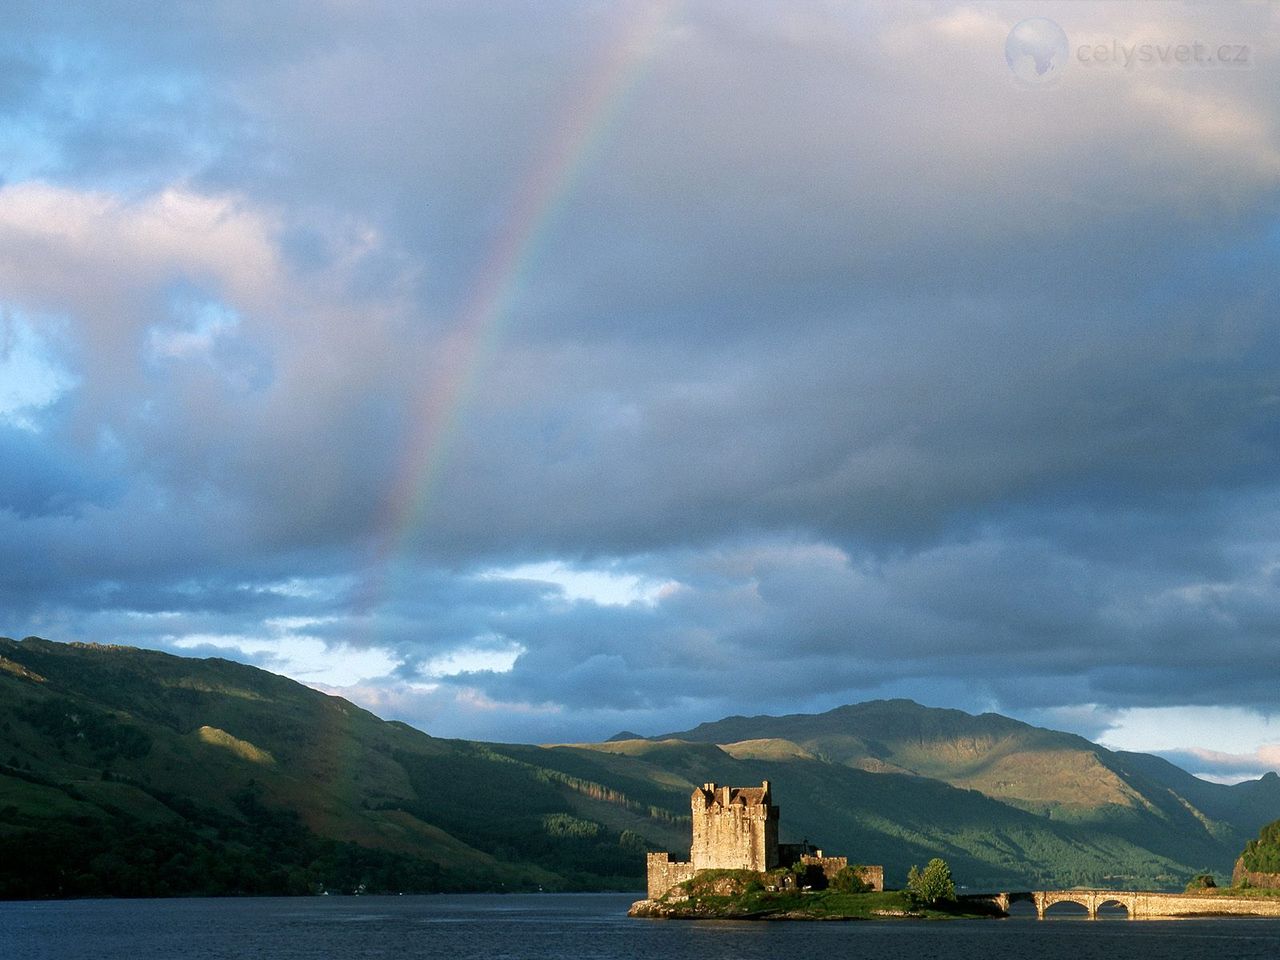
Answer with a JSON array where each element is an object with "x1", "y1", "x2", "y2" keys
[{"x1": 0, "y1": 637, "x2": 1280, "y2": 897}]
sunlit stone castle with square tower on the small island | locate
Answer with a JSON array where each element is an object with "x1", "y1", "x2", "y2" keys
[{"x1": 648, "y1": 781, "x2": 884, "y2": 900}]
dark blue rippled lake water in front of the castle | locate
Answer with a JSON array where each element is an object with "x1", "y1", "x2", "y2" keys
[{"x1": 0, "y1": 893, "x2": 1280, "y2": 960}]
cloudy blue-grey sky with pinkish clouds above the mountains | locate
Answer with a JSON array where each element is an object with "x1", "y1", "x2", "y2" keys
[{"x1": 0, "y1": 0, "x2": 1280, "y2": 781}]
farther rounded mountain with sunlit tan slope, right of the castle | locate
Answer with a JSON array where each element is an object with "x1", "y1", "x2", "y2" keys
[{"x1": 645, "y1": 700, "x2": 1280, "y2": 873}]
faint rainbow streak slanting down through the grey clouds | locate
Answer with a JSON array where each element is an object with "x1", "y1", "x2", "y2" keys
[{"x1": 357, "y1": 0, "x2": 677, "y2": 627}]
